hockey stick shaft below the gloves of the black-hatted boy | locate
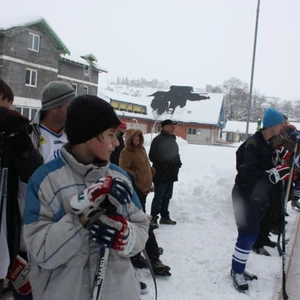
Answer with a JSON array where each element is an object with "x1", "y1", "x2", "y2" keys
[{"x1": 93, "y1": 247, "x2": 109, "y2": 300}]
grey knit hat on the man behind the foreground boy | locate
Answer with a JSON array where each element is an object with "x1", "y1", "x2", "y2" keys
[{"x1": 42, "y1": 81, "x2": 76, "y2": 111}]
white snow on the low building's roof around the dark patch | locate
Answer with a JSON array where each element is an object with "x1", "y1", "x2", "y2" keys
[{"x1": 98, "y1": 90, "x2": 223, "y2": 125}]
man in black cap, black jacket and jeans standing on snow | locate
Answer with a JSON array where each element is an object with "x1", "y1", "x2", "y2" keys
[{"x1": 149, "y1": 119, "x2": 182, "y2": 228}]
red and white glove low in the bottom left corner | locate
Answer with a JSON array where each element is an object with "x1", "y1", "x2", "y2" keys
[{"x1": 6, "y1": 255, "x2": 31, "y2": 296}]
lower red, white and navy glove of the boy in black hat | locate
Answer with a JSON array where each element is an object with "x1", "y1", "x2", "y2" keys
[{"x1": 90, "y1": 215, "x2": 134, "y2": 253}]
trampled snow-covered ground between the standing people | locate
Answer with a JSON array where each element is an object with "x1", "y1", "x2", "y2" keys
[{"x1": 141, "y1": 135, "x2": 297, "y2": 300}]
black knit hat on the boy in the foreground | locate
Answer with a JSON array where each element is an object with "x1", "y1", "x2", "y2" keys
[{"x1": 65, "y1": 95, "x2": 121, "y2": 145}]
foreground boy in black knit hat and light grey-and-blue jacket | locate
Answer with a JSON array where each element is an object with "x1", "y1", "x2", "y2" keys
[{"x1": 24, "y1": 95, "x2": 149, "y2": 300}]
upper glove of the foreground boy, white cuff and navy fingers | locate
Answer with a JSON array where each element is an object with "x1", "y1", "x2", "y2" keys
[{"x1": 70, "y1": 176, "x2": 132, "y2": 219}]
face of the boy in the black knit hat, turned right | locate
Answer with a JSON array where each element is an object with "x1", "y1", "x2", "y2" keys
[{"x1": 90, "y1": 127, "x2": 119, "y2": 161}]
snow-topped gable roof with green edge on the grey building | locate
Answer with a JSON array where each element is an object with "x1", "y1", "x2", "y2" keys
[{"x1": 0, "y1": 17, "x2": 70, "y2": 54}]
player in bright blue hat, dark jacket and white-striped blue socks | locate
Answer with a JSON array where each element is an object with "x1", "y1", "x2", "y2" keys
[{"x1": 231, "y1": 108, "x2": 290, "y2": 291}]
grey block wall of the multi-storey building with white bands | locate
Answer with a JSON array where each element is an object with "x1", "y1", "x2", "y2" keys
[{"x1": 0, "y1": 25, "x2": 99, "y2": 102}]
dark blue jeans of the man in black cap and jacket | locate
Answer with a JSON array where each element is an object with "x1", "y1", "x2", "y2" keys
[{"x1": 151, "y1": 182, "x2": 174, "y2": 219}]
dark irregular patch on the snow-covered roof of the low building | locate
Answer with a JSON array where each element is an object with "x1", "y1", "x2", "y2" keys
[{"x1": 149, "y1": 85, "x2": 210, "y2": 115}]
